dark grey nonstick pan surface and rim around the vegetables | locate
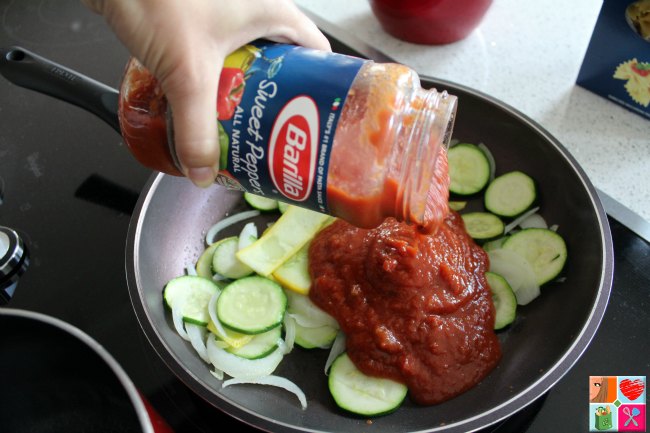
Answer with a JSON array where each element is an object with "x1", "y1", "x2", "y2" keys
[{"x1": 126, "y1": 79, "x2": 613, "y2": 432}]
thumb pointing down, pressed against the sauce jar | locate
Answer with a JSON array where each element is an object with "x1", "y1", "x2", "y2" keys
[{"x1": 161, "y1": 62, "x2": 223, "y2": 187}]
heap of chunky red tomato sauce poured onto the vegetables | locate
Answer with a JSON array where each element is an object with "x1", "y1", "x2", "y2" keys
[{"x1": 309, "y1": 212, "x2": 501, "y2": 405}]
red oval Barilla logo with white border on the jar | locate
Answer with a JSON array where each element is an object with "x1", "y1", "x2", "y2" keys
[{"x1": 268, "y1": 95, "x2": 319, "y2": 202}]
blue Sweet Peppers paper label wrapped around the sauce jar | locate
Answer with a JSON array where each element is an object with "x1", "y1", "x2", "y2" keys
[{"x1": 217, "y1": 42, "x2": 365, "y2": 213}]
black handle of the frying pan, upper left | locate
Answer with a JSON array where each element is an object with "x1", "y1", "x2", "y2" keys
[{"x1": 0, "y1": 47, "x2": 120, "y2": 133}]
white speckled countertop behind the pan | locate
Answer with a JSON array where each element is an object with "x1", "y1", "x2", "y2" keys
[{"x1": 296, "y1": 0, "x2": 650, "y2": 221}]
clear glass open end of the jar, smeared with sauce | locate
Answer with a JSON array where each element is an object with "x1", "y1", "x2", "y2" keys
[{"x1": 327, "y1": 64, "x2": 455, "y2": 233}]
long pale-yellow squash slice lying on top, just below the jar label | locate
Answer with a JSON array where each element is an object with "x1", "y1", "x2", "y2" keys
[{"x1": 237, "y1": 206, "x2": 331, "y2": 276}]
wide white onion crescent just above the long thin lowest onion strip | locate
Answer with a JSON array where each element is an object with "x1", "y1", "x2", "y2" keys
[{"x1": 207, "y1": 334, "x2": 284, "y2": 378}]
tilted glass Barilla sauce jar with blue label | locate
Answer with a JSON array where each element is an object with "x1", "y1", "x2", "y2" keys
[{"x1": 119, "y1": 41, "x2": 456, "y2": 229}]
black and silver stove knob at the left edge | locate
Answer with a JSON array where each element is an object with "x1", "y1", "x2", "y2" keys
[{"x1": 0, "y1": 226, "x2": 29, "y2": 305}]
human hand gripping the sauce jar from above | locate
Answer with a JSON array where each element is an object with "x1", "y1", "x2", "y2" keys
[{"x1": 82, "y1": 0, "x2": 330, "y2": 187}]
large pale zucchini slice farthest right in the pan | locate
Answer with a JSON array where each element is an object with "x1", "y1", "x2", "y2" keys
[{"x1": 503, "y1": 228, "x2": 567, "y2": 286}]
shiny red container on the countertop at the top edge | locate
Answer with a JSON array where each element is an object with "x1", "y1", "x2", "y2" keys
[{"x1": 370, "y1": 0, "x2": 492, "y2": 45}]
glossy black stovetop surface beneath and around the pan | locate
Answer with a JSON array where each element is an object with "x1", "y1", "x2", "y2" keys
[{"x1": 0, "y1": 0, "x2": 650, "y2": 433}]
